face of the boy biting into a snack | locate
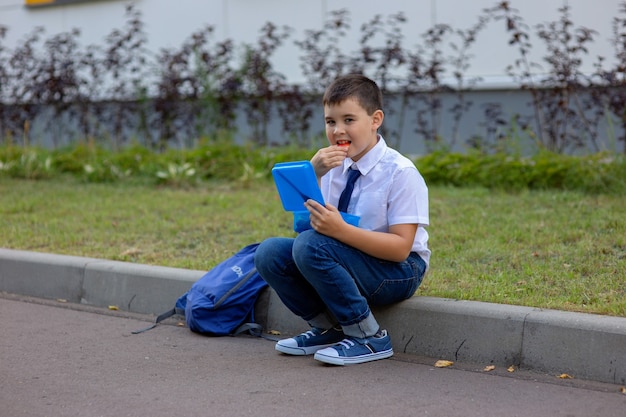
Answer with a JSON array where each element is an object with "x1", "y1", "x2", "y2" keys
[{"x1": 324, "y1": 98, "x2": 384, "y2": 161}]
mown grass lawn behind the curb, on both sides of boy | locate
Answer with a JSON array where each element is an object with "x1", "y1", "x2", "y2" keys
[{"x1": 0, "y1": 179, "x2": 626, "y2": 317}]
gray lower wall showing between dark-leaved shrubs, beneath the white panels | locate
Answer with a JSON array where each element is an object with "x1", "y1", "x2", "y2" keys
[{"x1": 14, "y1": 90, "x2": 624, "y2": 155}]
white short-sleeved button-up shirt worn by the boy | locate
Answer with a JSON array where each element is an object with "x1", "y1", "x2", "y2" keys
[{"x1": 321, "y1": 135, "x2": 430, "y2": 264}]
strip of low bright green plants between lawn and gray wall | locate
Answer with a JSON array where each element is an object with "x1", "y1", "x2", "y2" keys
[{"x1": 0, "y1": 141, "x2": 626, "y2": 194}]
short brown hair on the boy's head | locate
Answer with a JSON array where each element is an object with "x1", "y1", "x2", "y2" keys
[{"x1": 322, "y1": 74, "x2": 383, "y2": 115}]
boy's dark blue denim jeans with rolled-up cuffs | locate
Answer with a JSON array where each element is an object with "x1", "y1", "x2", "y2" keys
[{"x1": 254, "y1": 230, "x2": 426, "y2": 337}]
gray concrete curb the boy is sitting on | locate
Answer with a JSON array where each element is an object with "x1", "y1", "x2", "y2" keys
[{"x1": 0, "y1": 249, "x2": 626, "y2": 384}]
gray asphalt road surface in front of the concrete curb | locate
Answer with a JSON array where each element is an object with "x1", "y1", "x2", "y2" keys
[{"x1": 0, "y1": 294, "x2": 626, "y2": 417}]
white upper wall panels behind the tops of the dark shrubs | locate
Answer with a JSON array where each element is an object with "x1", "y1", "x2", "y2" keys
[{"x1": 0, "y1": 0, "x2": 621, "y2": 82}]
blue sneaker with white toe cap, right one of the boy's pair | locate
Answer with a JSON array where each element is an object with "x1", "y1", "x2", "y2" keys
[{"x1": 314, "y1": 330, "x2": 393, "y2": 365}]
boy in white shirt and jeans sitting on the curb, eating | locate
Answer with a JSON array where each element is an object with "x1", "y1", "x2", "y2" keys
[{"x1": 255, "y1": 75, "x2": 430, "y2": 365}]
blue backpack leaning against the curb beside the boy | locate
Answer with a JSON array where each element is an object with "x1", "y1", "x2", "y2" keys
[{"x1": 133, "y1": 243, "x2": 267, "y2": 336}]
